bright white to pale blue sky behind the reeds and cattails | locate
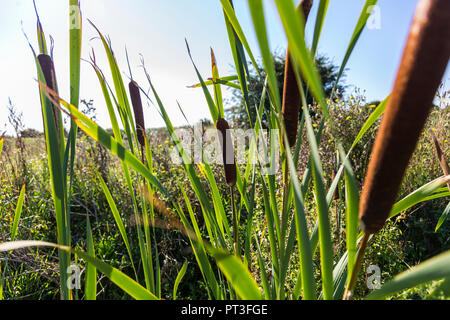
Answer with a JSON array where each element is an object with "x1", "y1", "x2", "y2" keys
[{"x1": 0, "y1": 0, "x2": 450, "y2": 133}]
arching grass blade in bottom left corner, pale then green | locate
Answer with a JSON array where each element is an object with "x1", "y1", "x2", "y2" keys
[{"x1": 0, "y1": 241, "x2": 158, "y2": 300}]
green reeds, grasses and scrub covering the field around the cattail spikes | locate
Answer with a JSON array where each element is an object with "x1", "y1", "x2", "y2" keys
[{"x1": 0, "y1": 0, "x2": 450, "y2": 300}]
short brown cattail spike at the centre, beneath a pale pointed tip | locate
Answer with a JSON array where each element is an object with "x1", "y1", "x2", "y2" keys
[{"x1": 216, "y1": 118, "x2": 237, "y2": 187}]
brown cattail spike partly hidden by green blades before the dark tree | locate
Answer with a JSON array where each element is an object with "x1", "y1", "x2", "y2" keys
[{"x1": 282, "y1": 0, "x2": 313, "y2": 147}]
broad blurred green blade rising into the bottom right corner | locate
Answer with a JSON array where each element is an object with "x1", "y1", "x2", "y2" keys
[{"x1": 366, "y1": 251, "x2": 450, "y2": 300}]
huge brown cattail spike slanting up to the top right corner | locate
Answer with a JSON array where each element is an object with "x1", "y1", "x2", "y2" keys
[{"x1": 360, "y1": 0, "x2": 450, "y2": 234}]
